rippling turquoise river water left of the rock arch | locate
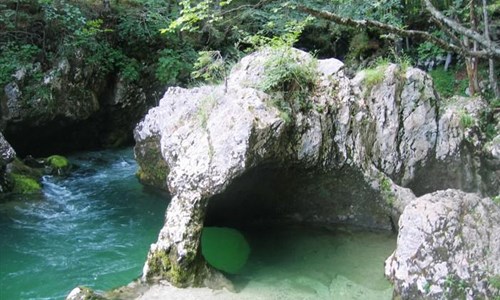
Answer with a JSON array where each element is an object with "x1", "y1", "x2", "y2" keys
[{"x1": 0, "y1": 149, "x2": 167, "y2": 300}]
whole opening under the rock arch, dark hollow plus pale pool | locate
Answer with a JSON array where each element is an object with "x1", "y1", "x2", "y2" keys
[{"x1": 202, "y1": 164, "x2": 396, "y2": 299}]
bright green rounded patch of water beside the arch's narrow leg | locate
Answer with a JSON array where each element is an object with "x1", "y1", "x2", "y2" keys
[{"x1": 201, "y1": 227, "x2": 250, "y2": 274}]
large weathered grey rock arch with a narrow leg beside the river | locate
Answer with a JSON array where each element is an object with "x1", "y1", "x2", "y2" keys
[{"x1": 134, "y1": 50, "x2": 498, "y2": 296}]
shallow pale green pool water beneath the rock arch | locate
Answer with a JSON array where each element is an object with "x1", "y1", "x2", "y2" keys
[{"x1": 232, "y1": 227, "x2": 396, "y2": 300}]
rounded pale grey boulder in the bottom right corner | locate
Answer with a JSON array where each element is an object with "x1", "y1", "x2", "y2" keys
[{"x1": 385, "y1": 190, "x2": 500, "y2": 299}]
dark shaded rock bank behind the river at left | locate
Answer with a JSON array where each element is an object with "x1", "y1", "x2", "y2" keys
[{"x1": 0, "y1": 52, "x2": 153, "y2": 157}]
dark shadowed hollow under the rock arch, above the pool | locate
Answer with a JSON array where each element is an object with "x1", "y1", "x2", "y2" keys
[{"x1": 204, "y1": 165, "x2": 391, "y2": 230}]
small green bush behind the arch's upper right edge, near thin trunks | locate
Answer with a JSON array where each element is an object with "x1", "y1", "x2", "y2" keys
[{"x1": 429, "y1": 68, "x2": 468, "y2": 98}]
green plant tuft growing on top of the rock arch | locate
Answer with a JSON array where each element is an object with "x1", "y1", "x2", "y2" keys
[{"x1": 259, "y1": 47, "x2": 318, "y2": 116}]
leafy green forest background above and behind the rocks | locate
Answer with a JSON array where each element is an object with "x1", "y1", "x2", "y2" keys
[{"x1": 0, "y1": 0, "x2": 500, "y2": 148}]
